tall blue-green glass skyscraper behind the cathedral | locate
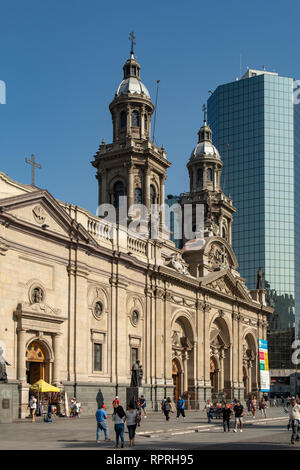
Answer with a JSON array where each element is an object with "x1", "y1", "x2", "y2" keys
[{"x1": 208, "y1": 70, "x2": 300, "y2": 368}]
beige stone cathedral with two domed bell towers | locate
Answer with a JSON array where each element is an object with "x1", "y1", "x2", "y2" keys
[{"x1": 0, "y1": 47, "x2": 272, "y2": 417}]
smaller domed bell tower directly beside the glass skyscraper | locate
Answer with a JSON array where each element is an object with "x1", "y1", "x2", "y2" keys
[{"x1": 181, "y1": 107, "x2": 235, "y2": 245}]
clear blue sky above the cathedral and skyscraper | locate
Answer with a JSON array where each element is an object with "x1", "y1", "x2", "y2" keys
[{"x1": 0, "y1": 0, "x2": 300, "y2": 213}]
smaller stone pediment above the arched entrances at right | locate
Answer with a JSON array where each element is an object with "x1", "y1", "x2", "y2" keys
[{"x1": 201, "y1": 270, "x2": 253, "y2": 302}]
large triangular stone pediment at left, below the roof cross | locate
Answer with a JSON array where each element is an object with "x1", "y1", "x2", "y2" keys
[{"x1": 0, "y1": 190, "x2": 96, "y2": 245}]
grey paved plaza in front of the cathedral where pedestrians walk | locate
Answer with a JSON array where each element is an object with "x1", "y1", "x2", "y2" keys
[{"x1": 0, "y1": 407, "x2": 300, "y2": 452}]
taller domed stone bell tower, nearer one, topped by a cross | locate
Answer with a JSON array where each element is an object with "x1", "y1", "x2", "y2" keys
[{"x1": 92, "y1": 37, "x2": 171, "y2": 226}]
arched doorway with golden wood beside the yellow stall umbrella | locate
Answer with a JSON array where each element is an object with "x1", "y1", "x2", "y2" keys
[{"x1": 26, "y1": 341, "x2": 49, "y2": 385}]
